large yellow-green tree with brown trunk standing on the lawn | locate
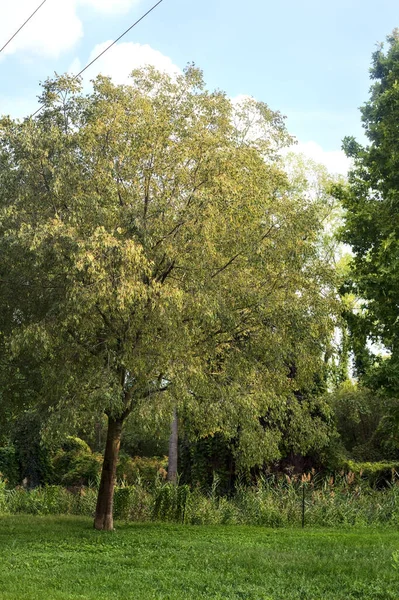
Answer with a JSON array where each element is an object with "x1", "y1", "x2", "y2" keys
[{"x1": 0, "y1": 67, "x2": 334, "y2": 529}]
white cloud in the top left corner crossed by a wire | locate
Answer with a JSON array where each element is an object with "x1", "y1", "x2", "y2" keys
[{"x1": 0, "y1": 0, "x2": 141, "y2": 58}]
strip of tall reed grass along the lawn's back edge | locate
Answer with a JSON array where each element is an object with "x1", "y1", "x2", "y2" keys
[{"x1": 0, "y1": 473, "x2": 399, "y2": 527}]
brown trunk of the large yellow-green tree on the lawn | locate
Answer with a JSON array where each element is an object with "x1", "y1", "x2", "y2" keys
[{"x1": 94, "y1": 417, "x2": 123, "y2": 531}]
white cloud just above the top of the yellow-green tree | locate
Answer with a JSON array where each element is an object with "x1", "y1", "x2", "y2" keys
[{"x1": 76, "y1": 41, "x2": 180, "y2": 84}]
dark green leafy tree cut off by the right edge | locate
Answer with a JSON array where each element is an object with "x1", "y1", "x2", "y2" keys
[{"x1": 342, "y1": 30, "x2": 399, "y2": 393}]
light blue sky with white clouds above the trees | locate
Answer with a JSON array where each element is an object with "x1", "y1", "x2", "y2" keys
[{"x1": 0, "y1": 0, "x2": 399, "y2": 173}]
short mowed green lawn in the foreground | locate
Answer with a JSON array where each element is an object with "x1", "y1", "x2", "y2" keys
[{"x1": 0, "y1": 515, "x2": 399, "y2": 600}]
